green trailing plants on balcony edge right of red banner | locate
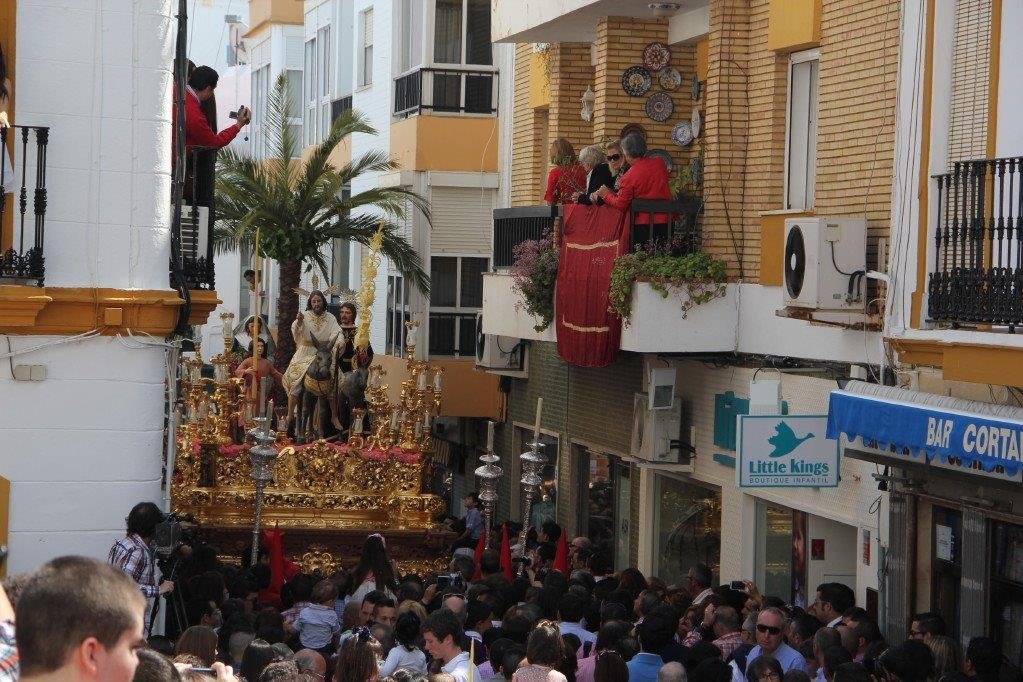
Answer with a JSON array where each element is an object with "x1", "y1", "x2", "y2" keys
[{"x1": 608, "y1": 245, "x2": 727, "y2": 324}]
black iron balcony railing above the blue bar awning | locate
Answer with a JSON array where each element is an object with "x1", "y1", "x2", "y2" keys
[{"x1": 927, "y1": 156, "x2": 1023, "y2": 332}]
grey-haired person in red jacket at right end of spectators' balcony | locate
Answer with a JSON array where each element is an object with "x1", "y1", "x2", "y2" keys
[{"x1": 589, "y1": 133, "x2": 671, "y2": 245}]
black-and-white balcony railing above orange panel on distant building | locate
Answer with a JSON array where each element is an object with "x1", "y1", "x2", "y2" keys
[{"x1": 394, "y1": 66, "x2": 497, "y2": 118}]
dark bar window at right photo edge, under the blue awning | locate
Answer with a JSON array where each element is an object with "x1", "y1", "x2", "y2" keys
[{"x1": 990, "y1": 522, "x2": 1023, "y2": 666}]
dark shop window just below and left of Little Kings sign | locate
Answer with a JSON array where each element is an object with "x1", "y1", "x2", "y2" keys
[{"x1": 654, "y1": 475, "x2": 721, "y2": 585}]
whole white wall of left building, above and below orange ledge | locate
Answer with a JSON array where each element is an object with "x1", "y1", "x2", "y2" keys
[{"x1": 0, "y1": 0, "x2": 177, "y2": 573}]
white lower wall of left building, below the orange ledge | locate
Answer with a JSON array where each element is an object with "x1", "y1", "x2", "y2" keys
[{"x1": 0, "y1": 336, "x2": 166, "y2": 573}]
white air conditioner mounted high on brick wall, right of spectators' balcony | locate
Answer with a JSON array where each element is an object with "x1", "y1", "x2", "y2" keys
[{"x1": 783, "y1": 217, "x2": 866, "y2": 311}]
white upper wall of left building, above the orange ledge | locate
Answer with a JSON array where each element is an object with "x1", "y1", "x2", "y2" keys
[{"x1": 12, "y1": 0, "x2": 176, "y2": 289}]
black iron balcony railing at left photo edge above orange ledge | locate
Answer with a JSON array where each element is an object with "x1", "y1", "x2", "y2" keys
[{"x1": 0, "y1": 126, "x2": 50, "y2": 286}]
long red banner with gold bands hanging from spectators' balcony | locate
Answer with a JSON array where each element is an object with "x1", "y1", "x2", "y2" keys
[{"x1": 554, "y1": 203, "x2": 629, "y2": 367}]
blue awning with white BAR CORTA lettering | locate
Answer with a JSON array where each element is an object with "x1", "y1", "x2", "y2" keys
[{"x1": 828, "y1": 381, "x2": 1023, "y2": 478}]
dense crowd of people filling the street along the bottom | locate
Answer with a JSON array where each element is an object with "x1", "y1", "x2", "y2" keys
[{"x1": 0, "y1": 503, "x2": 1020, "y2": 682}]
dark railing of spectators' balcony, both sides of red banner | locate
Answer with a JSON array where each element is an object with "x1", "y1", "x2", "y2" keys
[{"x1": 492, "y1": 198, "x2": 703, "y2": 268}]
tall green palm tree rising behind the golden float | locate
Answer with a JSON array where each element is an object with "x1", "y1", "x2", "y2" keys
[{"x1": 214, "y1": 74, "x2": 430, "y2": 369}]
